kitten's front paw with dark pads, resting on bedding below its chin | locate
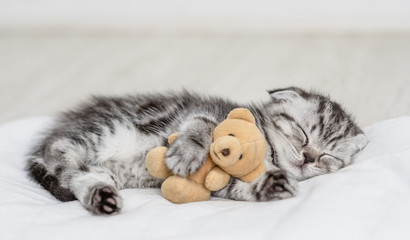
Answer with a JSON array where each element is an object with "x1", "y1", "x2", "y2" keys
[{"x1": 255, "y1": 170, "x2": 298, "y2": 201}]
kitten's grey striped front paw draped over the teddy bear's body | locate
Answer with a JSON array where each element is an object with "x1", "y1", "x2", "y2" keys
[{"x1": 165, "y1": 134, "x2": 209, "y2": 177}]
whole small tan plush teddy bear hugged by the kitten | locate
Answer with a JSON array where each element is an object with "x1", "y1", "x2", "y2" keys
[{"x1": 145, "y1": 108, "x2": 266, "y2": 203}]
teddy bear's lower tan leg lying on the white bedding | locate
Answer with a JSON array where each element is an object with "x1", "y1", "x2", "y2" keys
[{"x1": 161, "y1": 176, "x2": 211, "y2": 203}]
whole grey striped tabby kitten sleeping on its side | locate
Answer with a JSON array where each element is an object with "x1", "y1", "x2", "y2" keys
[{"x1": 28, "y1": 87, "x2": 367, "y2": 214}]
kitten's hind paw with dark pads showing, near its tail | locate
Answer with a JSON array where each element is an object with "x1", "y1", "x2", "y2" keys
[{"x1": 89, "y1": 186, "x2": 122, "y2": 215}]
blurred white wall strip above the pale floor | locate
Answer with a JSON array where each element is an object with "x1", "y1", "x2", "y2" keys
[{"x1": 0, "y1": 0, "x2": 410, "y2": 31}]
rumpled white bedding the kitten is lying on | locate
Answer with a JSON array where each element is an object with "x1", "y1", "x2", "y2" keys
[{"x1": 0, "y1": 117, "x2": 410, "y2": 240}]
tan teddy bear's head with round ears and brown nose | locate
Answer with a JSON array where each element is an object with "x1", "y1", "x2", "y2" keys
[{"x1": 210, "y1": 108, "x2": 266, "y2": 180}]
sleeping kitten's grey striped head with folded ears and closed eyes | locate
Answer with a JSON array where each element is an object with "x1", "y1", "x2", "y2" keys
[{"x1": 267, "y1": 87, "x2": 367, "y2": 180}]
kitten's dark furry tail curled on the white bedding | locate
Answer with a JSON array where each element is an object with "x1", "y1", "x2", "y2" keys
[{"x1": 27, "y1": 153, "x2": 77, "y2": 202}]
